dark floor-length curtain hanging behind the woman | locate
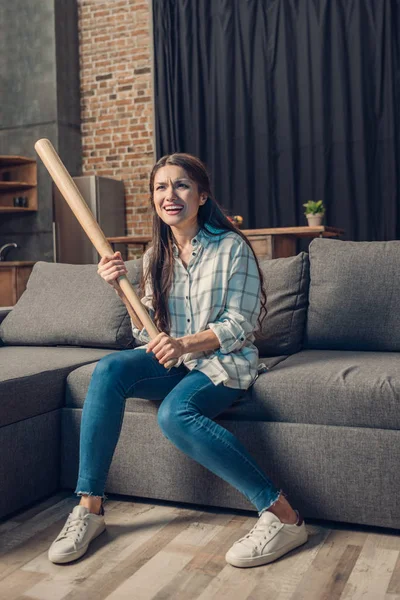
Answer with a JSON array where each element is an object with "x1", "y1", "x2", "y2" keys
[{"x1": 153, "y1": 0, "x2": 400, "y2": 240}]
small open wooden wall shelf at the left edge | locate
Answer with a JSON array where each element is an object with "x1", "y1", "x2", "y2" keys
[{"x1": 0, "y1": 155, "x2": 38, "y2": 213}]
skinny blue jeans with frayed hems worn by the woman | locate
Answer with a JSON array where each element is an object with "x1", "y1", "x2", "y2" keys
[{"x1": 75, "y1": 349, "x2": 280, "y2": 514}]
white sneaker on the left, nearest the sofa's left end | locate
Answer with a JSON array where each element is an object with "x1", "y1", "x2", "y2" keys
[{"x1": 48, "y1": 504, "x2": 106, "y2": 563}]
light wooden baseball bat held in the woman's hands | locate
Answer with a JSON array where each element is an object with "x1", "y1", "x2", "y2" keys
[{"x1": 35, "y1": 138, "x2": 177, "y2": 369}]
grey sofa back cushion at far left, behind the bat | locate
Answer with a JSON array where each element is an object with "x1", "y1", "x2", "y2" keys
[{"x1": 0, "y1": 258, "x2": 142, "y2": 349}]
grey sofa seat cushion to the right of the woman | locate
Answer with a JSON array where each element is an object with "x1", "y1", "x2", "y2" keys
[{"x1": 242, "y1": 350, "x2": 400, "y2": 430}]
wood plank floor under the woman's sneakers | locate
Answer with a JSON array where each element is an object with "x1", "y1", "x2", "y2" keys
[{"x1": 0, "y1": 491, "x2": 400, "y2": 600}]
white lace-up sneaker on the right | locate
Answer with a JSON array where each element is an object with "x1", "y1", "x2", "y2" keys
[{"x1": 225, "y1": 510, "x2": 308, "y2": 567}]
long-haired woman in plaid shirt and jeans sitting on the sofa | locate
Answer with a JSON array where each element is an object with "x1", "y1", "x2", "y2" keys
[{"x1": 49, "y1": 154, "x2": 307, "y2": 567}]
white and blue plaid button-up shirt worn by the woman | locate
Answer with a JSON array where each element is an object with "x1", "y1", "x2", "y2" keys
[{"x1": 131, "y1": 225, "x2": 266, "y2": 390}]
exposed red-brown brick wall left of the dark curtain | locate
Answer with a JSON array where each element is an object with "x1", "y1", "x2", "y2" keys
[{"x1": 78, "y1": 0, "x2": 155, "y2": 258}]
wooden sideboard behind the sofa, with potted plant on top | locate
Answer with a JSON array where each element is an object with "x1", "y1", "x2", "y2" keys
[{"x1": 107, "y1": 225, "x2": 344, "y2": 259}]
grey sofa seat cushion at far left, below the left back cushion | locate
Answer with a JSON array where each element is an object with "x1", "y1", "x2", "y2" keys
[{"x1": 0, "y1": 346, "x2": 115, "y2": 427}]
